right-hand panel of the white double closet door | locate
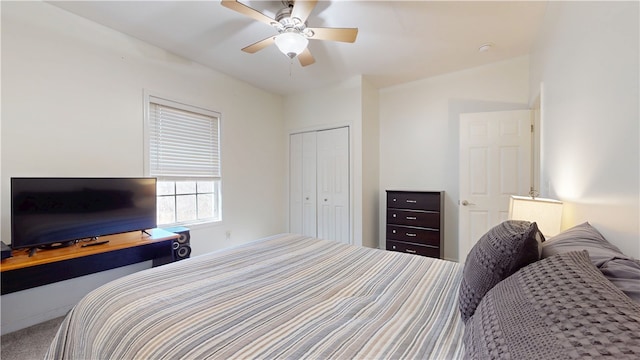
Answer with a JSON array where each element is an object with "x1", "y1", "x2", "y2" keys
[{"x1": 317, "y1": 127, "x2": 351, "y2": 244}]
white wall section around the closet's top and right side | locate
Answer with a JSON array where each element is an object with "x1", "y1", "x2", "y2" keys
[{"x1": 284, "y1": 76, "x2": 378, "y2": 247}]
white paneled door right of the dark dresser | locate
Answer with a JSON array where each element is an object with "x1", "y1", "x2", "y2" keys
[{"x1": 458, "y1": 110, "x2": 532, "y2": 263}]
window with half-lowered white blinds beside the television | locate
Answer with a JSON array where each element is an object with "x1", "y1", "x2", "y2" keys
[{"x1": 145, "y1": 95, "x2": 222, "y2": 226}]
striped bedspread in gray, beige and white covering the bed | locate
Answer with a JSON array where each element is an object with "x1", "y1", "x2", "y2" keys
[{"x1": 46, "y1": 234, "x2": 463, "y2": 359}]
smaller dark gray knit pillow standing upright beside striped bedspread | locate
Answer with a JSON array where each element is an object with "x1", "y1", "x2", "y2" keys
[{"x1": 458, "y1": 220, "x2": 544, "y2": 323}]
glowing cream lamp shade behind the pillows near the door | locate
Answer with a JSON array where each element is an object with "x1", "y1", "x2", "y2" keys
[{"x1": 509, "y1": 196, "x2": 562, "y2": 237}]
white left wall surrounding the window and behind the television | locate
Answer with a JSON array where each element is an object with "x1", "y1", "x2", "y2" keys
[{"x1": 0, "y1": 2, "x2": 286, "y2": 331}]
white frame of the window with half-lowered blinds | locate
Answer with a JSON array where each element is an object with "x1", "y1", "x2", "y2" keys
[{"x1": 143, "y1": 90, "x2": 223, "y2": 226}]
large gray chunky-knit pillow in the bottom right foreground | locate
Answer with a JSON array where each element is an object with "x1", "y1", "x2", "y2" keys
[{"x1": 464, "y1": 251, "x2": 640, "y2": 360}]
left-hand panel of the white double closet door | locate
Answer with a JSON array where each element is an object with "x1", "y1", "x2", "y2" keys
[{"x1": 289, "y1": 132, "x2": 317, "y2": 237}]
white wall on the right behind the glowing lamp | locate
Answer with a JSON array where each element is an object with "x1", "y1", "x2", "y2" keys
[{"x1": 530, "y1": 1, "x2": 640, "y2": 257}]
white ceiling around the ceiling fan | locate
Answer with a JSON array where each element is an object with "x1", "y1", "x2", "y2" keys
[{"x1": 50, "y1": 0, "x2": 546, "y2": 94}]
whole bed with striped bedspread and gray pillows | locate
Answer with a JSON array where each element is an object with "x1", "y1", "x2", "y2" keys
[{"x1": 46, "y1": 220, "x2": 640, "y2": 360}]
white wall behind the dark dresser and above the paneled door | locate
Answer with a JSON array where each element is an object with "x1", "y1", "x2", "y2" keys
[{"x1": 379, "y1": 57, "x2": 529, "y2": 260}]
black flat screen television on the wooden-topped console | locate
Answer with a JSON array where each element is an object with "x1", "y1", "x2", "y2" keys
[{"x1": 11, "y1": 177, "x2": 157, "y2": 249}]
